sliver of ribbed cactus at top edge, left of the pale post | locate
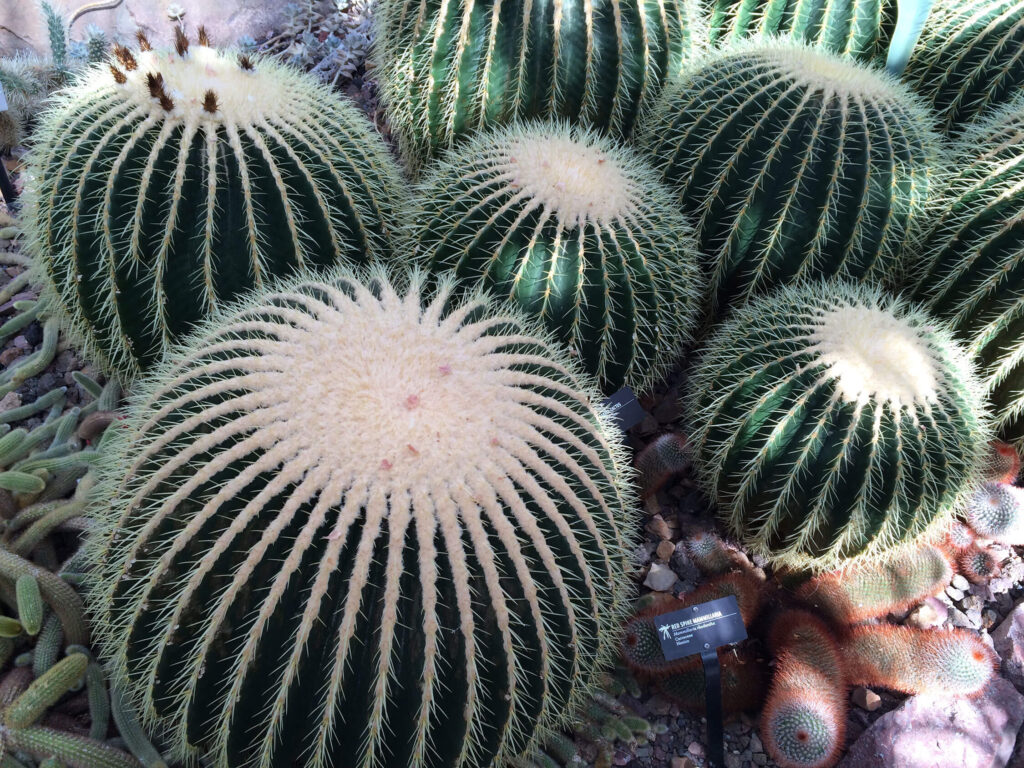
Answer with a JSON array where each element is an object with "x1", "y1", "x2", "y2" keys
[{"x1": 711, "y1": 0, "x2": 896, "y2": 61}]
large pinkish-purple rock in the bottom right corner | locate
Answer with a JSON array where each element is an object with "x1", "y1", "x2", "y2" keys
[{"x1": 839, "y1": 677, "x2": 1024, "y2": 768}]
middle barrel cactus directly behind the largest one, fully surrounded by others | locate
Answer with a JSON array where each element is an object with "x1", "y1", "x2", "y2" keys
[{"x1": 410, "y1": 124, "x2": 702, "y2": 391}]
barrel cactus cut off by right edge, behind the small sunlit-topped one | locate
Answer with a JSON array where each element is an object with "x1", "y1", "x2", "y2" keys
[{"x1": 908, "y1": 99, "x2": 1024, "y2": 449}]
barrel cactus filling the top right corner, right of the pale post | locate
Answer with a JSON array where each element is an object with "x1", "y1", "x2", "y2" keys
[{"x1": 903, "y1": 0, "x2": 1024, "y2": 133}]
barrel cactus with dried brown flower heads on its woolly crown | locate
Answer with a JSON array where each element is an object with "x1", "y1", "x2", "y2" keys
[{"x1": 27, "y1": 31, "x2": 400, "y2": 378}]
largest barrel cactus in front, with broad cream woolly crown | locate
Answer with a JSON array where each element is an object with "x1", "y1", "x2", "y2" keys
[{"x1": 87, "y1": 269, "x2": 634, "y2": 768}]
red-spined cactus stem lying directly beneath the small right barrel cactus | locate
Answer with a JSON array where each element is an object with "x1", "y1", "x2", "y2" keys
[{"x1": 798, "y1": 545, "x2": 953, "y2": 625}]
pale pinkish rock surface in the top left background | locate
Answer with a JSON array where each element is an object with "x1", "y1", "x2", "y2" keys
[{"x1": 0, "y1": 0, "x2": 323, "y2": 55}]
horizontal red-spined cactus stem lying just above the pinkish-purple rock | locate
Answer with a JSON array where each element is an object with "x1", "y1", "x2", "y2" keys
[{"x1": 841, "y1": 625, "x2": 997, "y2": 696}]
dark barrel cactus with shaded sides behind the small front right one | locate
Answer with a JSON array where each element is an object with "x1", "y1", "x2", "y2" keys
[{"x1": 642, "y1": 41, "x2": 942, "y2": 316}]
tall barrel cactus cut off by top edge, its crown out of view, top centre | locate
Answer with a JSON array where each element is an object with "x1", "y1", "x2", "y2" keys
[{"x1": 375, "y1": 0, "x2": 707, "y2": 169}]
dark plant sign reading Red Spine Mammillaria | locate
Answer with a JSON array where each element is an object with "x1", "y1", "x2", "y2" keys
[{"x1": 654, "y1": 595, "x2": 746, "y2": 662}]
